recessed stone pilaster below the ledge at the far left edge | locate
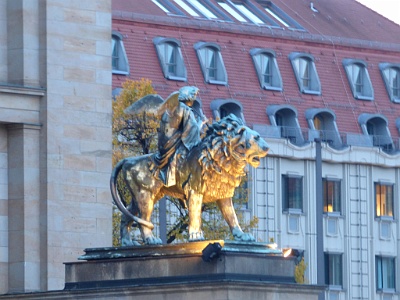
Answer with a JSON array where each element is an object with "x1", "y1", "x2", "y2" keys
[{"x1": 7, "y1": 124, "x2": 41, "y2": 293}]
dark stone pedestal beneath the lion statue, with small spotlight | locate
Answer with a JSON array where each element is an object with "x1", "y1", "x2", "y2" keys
[{"x1": 60, "y1": 240, "x2": 323, "y2": 300}]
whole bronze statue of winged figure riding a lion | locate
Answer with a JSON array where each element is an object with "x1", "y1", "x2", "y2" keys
[{"x1": 110, "y1": 86, "x2": 269, "y2": 246}]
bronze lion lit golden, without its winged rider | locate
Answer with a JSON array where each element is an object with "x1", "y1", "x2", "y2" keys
[{"x1": 110, "y1": 114, "x2": 269, "y2": 246}]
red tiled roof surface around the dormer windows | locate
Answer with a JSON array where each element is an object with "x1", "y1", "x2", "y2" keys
[{"x1": 113, "y1": 0, "x2": 400, "y2": 137}]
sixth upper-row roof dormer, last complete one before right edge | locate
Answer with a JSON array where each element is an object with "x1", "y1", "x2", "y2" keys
[{"x1": 343, "y1": 59, "x2": 374, "y2": 100}]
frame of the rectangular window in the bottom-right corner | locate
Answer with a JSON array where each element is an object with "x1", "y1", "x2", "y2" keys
[{"x1": 375, "y1": 255, "x2": 396, "y2": 292}]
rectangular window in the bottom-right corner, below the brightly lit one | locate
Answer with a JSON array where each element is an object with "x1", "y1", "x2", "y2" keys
[{"x1": 375, "y1": 256, "x2": 396, "y2": 291}]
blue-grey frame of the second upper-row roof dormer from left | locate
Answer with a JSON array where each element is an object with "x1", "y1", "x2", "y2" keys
[{"x1": 153, "y1": 37, "x2": 187, "y2": 81}]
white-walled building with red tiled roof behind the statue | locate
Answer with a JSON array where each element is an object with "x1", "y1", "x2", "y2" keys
[{"x1": 112, "y1": 0, "x2": 400, "y2": 300}]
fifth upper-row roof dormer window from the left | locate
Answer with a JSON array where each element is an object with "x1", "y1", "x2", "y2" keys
[{"x1": 289, "y1": 52, "x2": 321, "y2": 95}]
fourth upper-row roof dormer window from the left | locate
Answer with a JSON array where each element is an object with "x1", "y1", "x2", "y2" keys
[{"x1": 250, "y1": 48, "x2": 282, "y2": 91}]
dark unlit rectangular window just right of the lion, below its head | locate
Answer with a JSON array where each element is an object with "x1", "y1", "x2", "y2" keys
[{"x1": 282, "y1": 175, "x2": 303, "y2": 211}]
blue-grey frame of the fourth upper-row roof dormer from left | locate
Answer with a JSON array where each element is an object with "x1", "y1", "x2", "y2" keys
[{"x1": 249, "y1": 48, "x2": 283, "y2": 91}]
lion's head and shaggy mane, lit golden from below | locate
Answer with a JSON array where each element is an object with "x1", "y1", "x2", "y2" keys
[{"x1": 199, "y1": 115, "x2": 269, "y2": 202}]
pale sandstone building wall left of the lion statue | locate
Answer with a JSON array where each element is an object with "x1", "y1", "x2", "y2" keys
[{"x1": 0, "y1": 0, "x2": 112, "y2": 294}]
